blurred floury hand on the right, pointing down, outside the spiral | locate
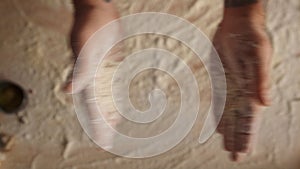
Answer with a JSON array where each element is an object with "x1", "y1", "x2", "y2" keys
[{"x1": 213, "y1": 12, "x2": 272, "y2": 161}]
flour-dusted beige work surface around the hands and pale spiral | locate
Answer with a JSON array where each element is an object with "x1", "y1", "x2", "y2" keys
[{"x1": 0, "y1": 0, "x2": 300, "y2": 169}]
